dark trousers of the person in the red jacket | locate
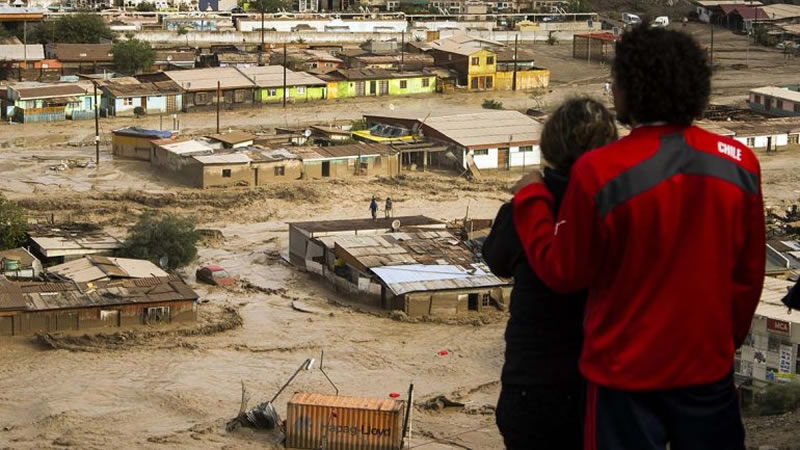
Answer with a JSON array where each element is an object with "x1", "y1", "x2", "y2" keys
[{"x1": 585, "y1": 373, "x2": 745, "y2": 450}]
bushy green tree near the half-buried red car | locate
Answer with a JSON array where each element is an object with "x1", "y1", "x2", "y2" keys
[{"x1": 120, "y1": 212, "x2": 200, "y2": 270}]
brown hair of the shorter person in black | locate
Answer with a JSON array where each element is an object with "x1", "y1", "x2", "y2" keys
[{"x1": 539, "y1": 97, "x2": 617, "y2": 175}]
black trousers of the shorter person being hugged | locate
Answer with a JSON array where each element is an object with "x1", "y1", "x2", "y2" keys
[{"x1": 496, "y1": 382, "x2": 585, "y2": 450}]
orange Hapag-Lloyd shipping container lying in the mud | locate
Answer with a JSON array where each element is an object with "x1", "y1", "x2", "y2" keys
[{"x1": 286, "y1": 392, "x2": 405, "y2": 450}]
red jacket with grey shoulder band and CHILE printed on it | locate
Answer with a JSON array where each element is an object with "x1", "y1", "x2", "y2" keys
[{"x1": 514, "y1": 126, "x2": 766, "y2": 390}]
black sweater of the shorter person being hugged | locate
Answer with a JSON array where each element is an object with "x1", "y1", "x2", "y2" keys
[{"x1": 483, "y1": 169, "x2": 586, "y2": 386}]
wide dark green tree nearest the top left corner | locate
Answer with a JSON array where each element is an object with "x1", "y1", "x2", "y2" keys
[{"x1": 28, "y1": 12, "x2": 114, "y2": 44}]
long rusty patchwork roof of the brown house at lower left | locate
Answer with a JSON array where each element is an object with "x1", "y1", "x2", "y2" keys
[{"x1": 0, "y1": 275, "x2": 198, "y2": 311}]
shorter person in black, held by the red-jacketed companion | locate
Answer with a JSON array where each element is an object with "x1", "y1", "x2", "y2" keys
[{"x1": 483, "y1": 98, "x2": 617, "y2": 450}]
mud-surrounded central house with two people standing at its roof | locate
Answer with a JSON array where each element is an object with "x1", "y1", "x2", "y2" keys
[{"x1": 290, "y1": 217, "x2": 511, "y2": 317}]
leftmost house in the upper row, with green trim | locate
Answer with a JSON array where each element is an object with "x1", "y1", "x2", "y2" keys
[{"x1": 3, "y1": 83, "x2": 99, "y2": 123}]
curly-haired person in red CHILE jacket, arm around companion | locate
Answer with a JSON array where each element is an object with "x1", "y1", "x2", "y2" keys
[{"x1": 513, "y1": 25, "x2": 765, "y2": 450}]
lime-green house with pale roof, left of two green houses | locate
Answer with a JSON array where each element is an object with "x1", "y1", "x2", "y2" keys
[{"x1": 238, "y1": 66, "x2": 328, "y2": 103}]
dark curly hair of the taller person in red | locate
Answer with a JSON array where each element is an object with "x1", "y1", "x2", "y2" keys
[{"x1": 612, "y1": 24, "x2": 711, "y2": 125}]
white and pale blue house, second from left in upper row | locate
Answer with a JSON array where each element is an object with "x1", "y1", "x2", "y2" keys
[{"x1": 101, "y1": 77, "x2": 183, "y2": 116}]
